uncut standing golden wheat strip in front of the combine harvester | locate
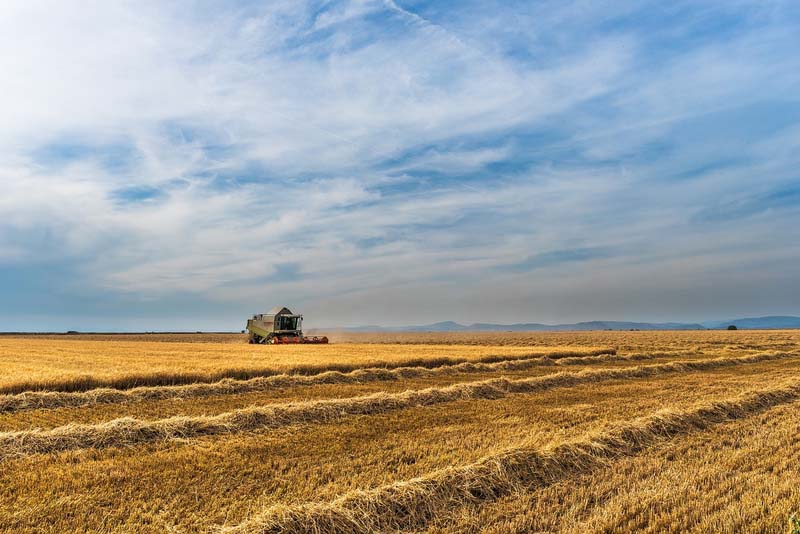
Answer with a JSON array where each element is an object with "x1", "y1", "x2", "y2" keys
[{"x1": 0, "y1": 337, "x2": 616, "y2": 394}]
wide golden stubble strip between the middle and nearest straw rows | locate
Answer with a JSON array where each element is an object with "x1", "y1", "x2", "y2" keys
[{"x1": 6, "y1": 359, "x2": 800, "y2": 533}]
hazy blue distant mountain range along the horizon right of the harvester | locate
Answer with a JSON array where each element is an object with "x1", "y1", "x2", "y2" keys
[{"x1": 315, "y1": 316, "x2": 800, "y2": 332}]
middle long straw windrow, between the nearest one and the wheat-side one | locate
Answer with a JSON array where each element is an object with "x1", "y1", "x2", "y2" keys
[{"x1": 0, "y1": 353, "x2": 796, "y2": 460}]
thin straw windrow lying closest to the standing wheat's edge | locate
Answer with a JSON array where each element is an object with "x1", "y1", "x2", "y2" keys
[{"x1": 0, "y1": 352, "x2": 674, "y2": 413}]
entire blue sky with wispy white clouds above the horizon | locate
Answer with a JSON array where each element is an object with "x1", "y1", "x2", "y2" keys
[{"x1": 0, "y1": 0, "x2": 800, "y2": 330}]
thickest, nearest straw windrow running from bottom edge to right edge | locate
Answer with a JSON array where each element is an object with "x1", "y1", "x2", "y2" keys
[{"x1": 223, "y1": 381, "x2": 800, "y2": 534}]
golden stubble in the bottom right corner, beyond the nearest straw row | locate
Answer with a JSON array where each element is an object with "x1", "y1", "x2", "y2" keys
[{"x1": 430, "y1": 403, "x2": 800, "y2": 534}]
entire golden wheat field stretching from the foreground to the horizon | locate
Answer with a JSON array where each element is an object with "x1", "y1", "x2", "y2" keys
[{"x1": 0, "y1": 331, "x2": 800, "y2": 533}]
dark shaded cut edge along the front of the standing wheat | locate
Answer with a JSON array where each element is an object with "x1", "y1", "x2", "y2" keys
[{"x1": 0, "y1": 348, "x2": 617, "y2": 394}]
